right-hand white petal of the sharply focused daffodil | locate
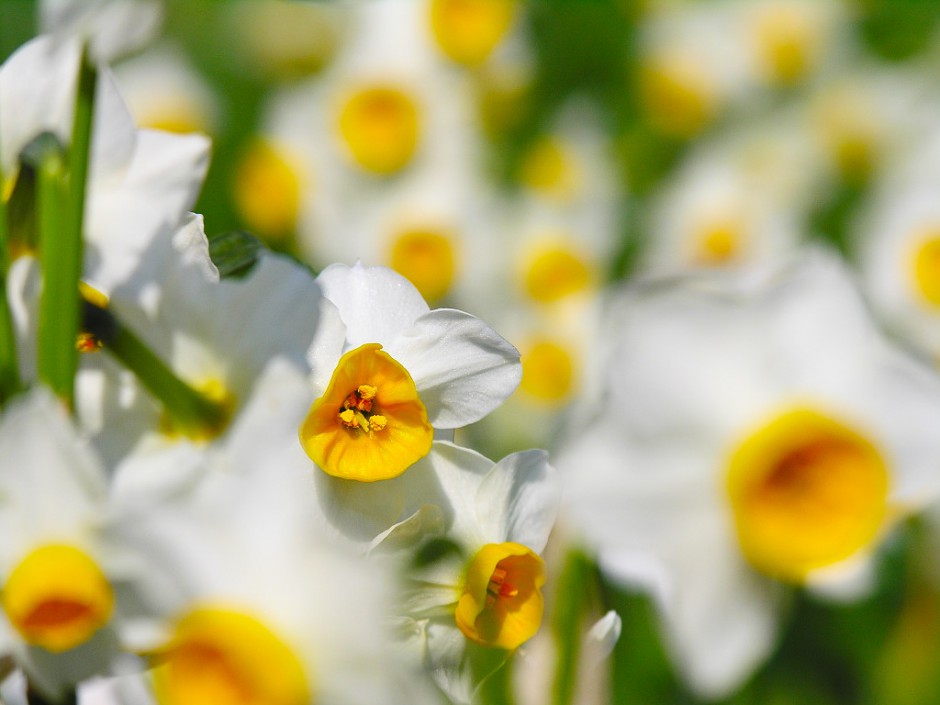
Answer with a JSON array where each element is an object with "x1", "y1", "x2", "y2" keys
[{"x1": 388, "y1": 309, "x2": 522, "y2": 428}]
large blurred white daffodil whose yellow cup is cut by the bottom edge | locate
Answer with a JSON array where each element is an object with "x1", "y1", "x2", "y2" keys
[{"x1": 115, "y1": 418, "x2": 436, "y2": 705}]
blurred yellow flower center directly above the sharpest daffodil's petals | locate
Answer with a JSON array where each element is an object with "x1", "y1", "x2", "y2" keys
[{"x1": 388, "y1": 229, "x2": 457, "y2": 302}]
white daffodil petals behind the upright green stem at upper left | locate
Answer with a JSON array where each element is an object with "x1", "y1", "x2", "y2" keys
[{"x1": 0, "y1": 37, "x2": 209, "y2": 302}]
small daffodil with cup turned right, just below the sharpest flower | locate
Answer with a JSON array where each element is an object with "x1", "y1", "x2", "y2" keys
[{"x1": 392, "y1": 441, "x2": 558, "y2": 703}]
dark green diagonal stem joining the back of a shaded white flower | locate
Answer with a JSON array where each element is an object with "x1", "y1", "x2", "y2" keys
[{"x1": 84, "y1": 301, "x2": 231, "y2": 439}]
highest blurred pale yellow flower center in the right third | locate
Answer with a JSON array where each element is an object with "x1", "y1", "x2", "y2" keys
[{"x1": 754, "y1": 3, "x2": 821, "y2": 85}]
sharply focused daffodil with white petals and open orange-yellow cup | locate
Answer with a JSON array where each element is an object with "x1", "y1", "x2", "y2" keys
[{"x1": 300, "y1": 265, "x2": 520, "y2": 482}]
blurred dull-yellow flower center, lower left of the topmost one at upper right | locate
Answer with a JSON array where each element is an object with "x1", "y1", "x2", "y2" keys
[{"x1": 640, "y1": 55, "x2": 717, "y2": 137}]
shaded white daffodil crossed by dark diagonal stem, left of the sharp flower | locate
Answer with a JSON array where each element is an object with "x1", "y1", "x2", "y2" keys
[{"x1": 80, "y1": 216, "x2": 320, "y2": 472}]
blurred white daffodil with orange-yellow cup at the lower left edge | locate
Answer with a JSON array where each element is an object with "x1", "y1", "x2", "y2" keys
[{"x1": 0, "y1": 388, "x2": 130, "y2": 699}]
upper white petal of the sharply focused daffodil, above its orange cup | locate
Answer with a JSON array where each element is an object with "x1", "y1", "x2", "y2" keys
[{"x1": 317, "y1": 264, "x2": 428, "y2": 348}]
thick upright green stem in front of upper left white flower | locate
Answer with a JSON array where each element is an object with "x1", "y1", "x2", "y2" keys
[{"x1": 37, "y1": 53, "x2": 97, "y2": 406}]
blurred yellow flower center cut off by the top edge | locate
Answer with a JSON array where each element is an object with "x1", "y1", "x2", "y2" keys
[{"x1": 431, "y1": 0, "x2": 515, "y2": 66}]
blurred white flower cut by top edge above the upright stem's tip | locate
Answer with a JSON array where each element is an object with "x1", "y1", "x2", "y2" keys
[{"x1": 39, "y1": 0, "x2": 163, "y2": 62}]
